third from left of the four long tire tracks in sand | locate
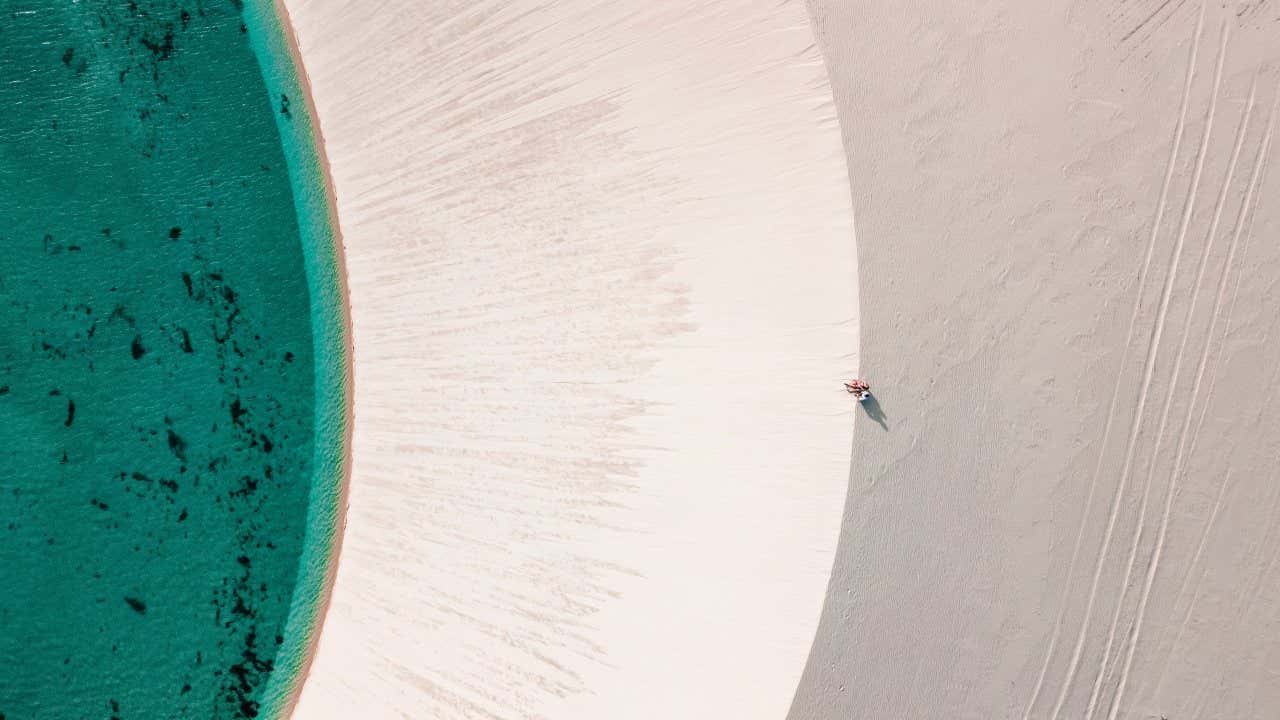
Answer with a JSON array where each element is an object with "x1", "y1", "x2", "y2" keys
[{"x1": 1084, "y1": 57, "x2": 1258, "y2": 720}]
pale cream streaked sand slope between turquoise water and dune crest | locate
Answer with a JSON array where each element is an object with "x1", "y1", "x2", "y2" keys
[{"x1": 285, "y1": 0, "x2": 858, "y2": 720}]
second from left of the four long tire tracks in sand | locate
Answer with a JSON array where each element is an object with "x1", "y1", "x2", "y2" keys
[{"x1": 1052, "y1": 14, "x2": 1229, "y2": 720}]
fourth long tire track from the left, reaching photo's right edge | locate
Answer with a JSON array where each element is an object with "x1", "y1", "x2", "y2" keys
[{"x1": 1107, "y1": 71, "x2": 1280, "y2": 720}]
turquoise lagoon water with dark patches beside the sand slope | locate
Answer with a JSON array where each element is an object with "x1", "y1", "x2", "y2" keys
[{"x1": 0, "y1": 0, "x2": 346, "y2": 720}]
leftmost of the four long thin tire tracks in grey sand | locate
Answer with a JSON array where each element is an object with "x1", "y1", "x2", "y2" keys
[{"x1": 1023, "y1": 1, "x2": 1204, "y2": 720}]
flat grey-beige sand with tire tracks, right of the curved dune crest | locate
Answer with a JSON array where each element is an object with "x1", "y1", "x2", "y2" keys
[{"x1": 791, "y1": 0, "x2": 1280, "y2": 720}]
